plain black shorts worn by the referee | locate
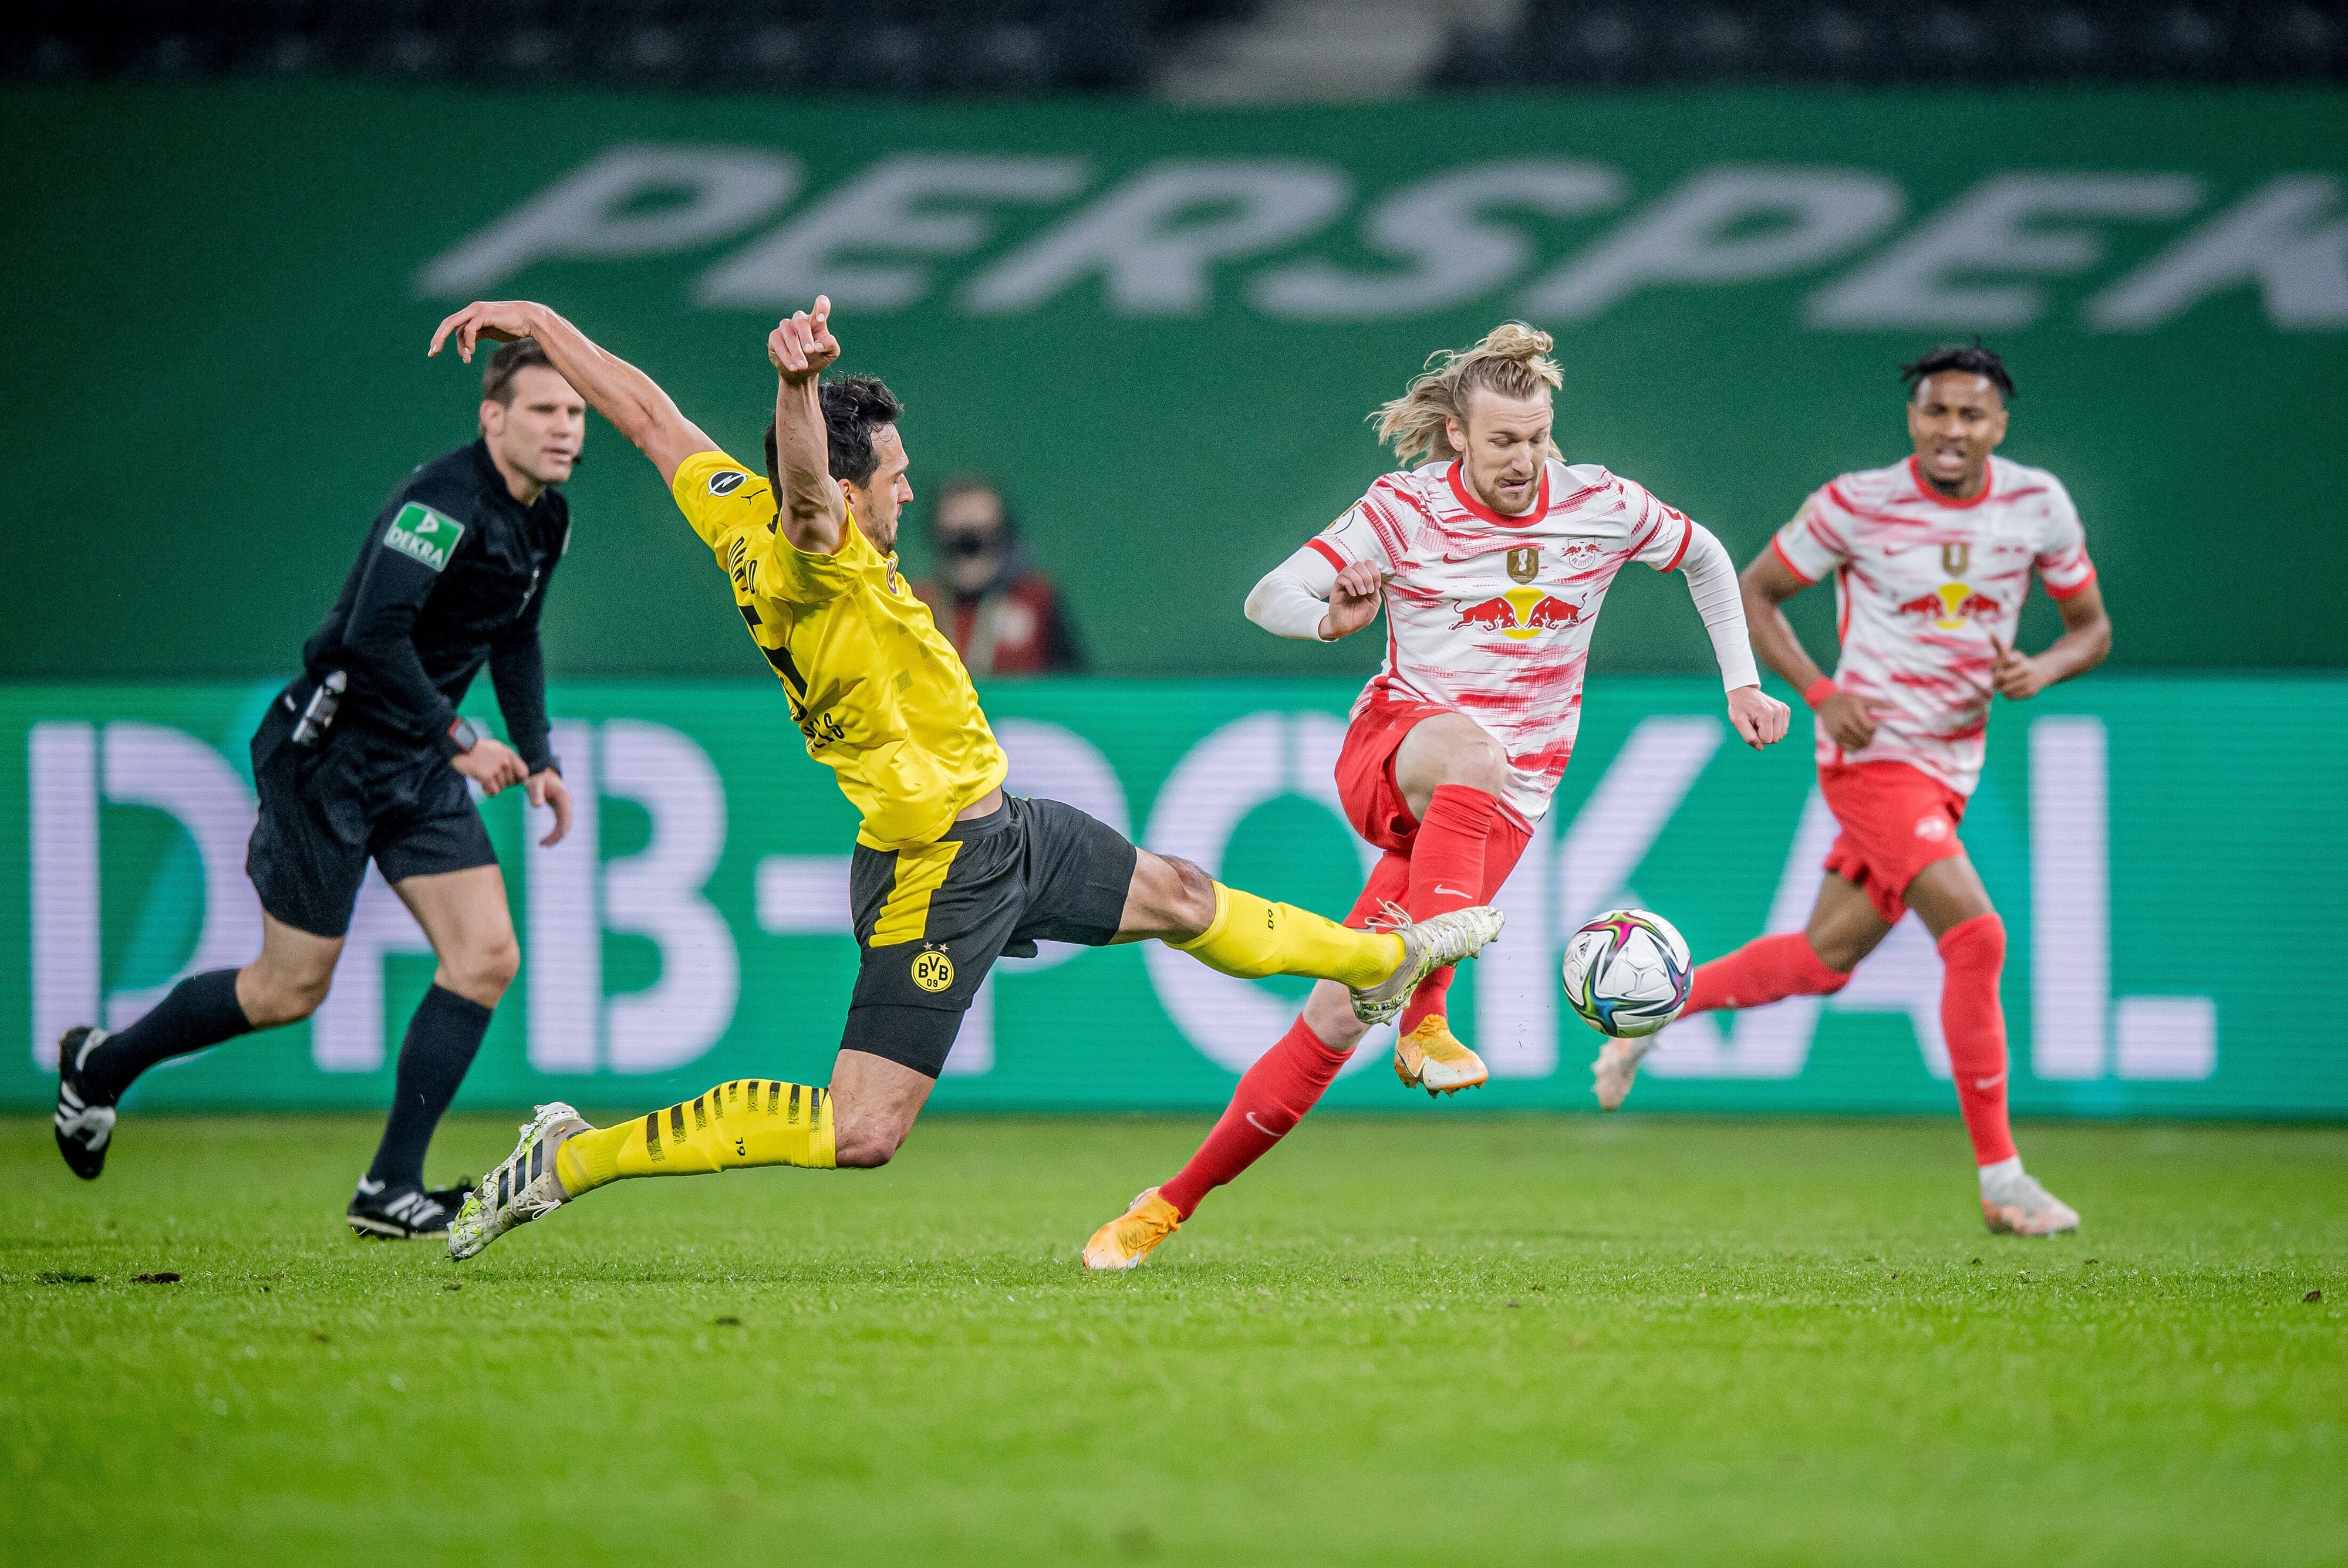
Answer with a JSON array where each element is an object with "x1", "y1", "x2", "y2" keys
[{"x1": 244, "y1": 688, "x2": 498, "y2": 937}]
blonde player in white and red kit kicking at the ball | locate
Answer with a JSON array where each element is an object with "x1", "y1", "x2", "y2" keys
[{"x1": 1085, "y1": 322, "x2": 1787, "y2": 1268}]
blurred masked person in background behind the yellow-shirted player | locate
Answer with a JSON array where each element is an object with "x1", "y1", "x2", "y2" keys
[{"x1": 913, "y1": 474, "x2": 1085, "y2": 678}]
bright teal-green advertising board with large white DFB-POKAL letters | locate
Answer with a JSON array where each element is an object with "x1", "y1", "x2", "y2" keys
[{"x1": 0, "y1": 676, "x2": 2348, "y2": 1117}]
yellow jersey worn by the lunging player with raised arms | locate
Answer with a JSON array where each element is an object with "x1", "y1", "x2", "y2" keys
[{"x1": 669, "y1": 453, "x2": 1010, "y2": 850}]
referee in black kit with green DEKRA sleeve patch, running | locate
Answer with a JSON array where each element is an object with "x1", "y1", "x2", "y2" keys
[{"x1": 56, "y1": 338, "x2": 587, "y2": 1239}]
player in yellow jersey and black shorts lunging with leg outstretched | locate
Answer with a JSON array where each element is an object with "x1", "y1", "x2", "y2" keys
[{"x1": 430, "y1": 298, "x2": 1500, "y2": 1258}]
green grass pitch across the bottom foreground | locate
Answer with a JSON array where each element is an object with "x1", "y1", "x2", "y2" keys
[{"x1": 0, "y1": 1115, "x2": 2348, "y2": 1568}]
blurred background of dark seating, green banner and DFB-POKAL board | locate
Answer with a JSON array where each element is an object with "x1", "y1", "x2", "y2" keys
[{"x1": 0, "y1": 0, "x2": 2348, "y2": 1117}]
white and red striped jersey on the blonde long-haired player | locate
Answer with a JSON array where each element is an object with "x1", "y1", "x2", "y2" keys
[{"x1": 1310, "y1": 458, "x2": 1709, "y2": 822}]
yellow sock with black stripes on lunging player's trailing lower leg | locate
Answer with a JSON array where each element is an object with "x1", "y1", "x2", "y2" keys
[{"x1": 554, "y1": 1077, "x2": 834, "y2": 1197}]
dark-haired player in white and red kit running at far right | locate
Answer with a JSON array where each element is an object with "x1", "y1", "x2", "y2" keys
[{"x1": 1592, "y1": 347, "x2": 2111, "y2": 1235}]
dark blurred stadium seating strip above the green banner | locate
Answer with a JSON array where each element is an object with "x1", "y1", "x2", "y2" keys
[{"x1": 18, "y1": 0, "x2": 2348, "y2": 96}]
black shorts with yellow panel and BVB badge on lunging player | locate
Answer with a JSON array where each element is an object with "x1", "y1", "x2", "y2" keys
[{"x1": 841, "y1": 796, "x2": 1139, "y2": 1077}]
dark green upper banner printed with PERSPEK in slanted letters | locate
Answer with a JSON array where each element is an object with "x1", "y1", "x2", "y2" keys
[{"x1": 0, "y1": 82, "x2": 2348, "y2": 681}]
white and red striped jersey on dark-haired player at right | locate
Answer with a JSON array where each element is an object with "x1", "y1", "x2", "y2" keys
[{"x1": 1770, "y1": 458, "x2": 2094, "y2": 796}]
